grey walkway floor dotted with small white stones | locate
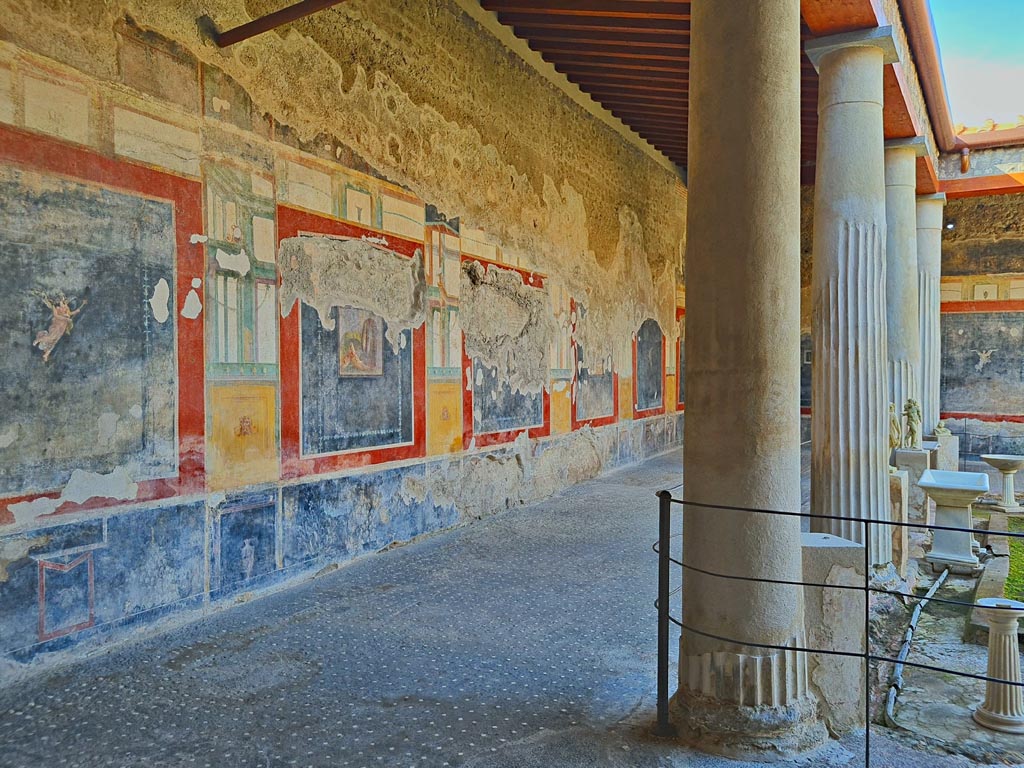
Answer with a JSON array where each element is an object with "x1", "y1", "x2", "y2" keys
[{"x1": 0, "y1": 452, "x2": 999, "y2": 768}]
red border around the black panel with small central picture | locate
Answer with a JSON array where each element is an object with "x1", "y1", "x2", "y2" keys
[{"x1": 278, "y1": 205, "x2": 427, "y2": 479}]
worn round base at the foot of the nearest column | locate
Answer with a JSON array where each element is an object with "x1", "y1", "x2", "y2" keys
[{"x1": 672, "y1": 689, "x2": 828, "y2": 762}]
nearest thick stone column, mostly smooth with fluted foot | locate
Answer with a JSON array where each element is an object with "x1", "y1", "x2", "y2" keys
[{"x1": 675, "y1": 0, "x2": 825, "y2": 757}]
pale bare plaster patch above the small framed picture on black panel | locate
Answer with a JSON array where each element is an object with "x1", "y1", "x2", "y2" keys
[{"x1": 279, "y1": 237, "x2": 426, "y2": 353}]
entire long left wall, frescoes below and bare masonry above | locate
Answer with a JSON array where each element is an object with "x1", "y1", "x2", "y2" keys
[{"x1": 0, "y1": 0, "x2": 686, "y2": 675}]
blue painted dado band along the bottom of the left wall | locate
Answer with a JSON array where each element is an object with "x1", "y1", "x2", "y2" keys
[{"x1": 0, "y1": 414, "x2": 683, "y2": 677}]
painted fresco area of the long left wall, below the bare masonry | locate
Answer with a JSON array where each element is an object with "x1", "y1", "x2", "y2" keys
[{"x1": 0, "y1": 33, "x2": 682, "y2": 660}]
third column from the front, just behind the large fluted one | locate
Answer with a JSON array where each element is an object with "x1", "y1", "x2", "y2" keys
[{"x1": 885, "y1": 137, "x2": 925, "y2": 423}]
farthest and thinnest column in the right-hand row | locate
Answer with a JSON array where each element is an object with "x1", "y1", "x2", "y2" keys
[{"x1": 918, "y1": 193, "x2": 946, "y2": 434}]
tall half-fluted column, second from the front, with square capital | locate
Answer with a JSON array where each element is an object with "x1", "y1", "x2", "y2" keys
[{"x1": 807, "y1": 27, "x2": 896, "y2": 565}]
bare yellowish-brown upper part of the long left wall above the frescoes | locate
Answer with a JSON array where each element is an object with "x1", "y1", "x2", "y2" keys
[{"x1": 0, "y1": 0, "x2": 686, "y2": 372}]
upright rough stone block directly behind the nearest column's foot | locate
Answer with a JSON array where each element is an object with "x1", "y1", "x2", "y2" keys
[{"x1": 801, "y1": 534, "x2": 864, "y2": 733}]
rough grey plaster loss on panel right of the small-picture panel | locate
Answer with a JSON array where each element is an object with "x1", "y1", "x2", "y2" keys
[{"x1": 460, "y1": 261, "x2": 555, "y2": 393}]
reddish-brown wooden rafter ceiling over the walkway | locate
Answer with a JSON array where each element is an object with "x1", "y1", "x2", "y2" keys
[{"x1": 479, "y1": 0, "x2": 935, "y2": 191}]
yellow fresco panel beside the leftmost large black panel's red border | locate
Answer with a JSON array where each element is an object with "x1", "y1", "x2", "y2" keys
[{"x1": 207, "y1": 384, "x2": 280, "y2": 490}]
